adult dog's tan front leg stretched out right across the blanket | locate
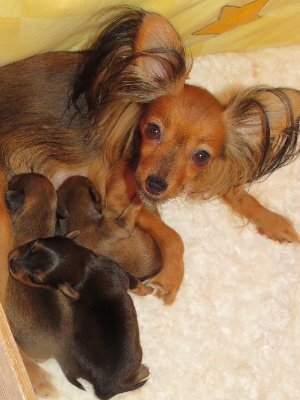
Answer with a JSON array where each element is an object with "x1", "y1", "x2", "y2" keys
[{"x1": 223, "y1": 187, "x2": 299, "y2": 242}]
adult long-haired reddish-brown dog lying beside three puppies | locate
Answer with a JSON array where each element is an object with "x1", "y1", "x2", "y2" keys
[{"x1": 0, "y1": 7, "x2": 300, "y2": 394}]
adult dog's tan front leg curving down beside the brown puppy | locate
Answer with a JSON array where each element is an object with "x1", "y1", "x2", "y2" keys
[{"x1": 137, "y1": 207, "x2": 184, "y2": 305}]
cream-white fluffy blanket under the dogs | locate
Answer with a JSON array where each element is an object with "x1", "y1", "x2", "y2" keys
[{"x1": 38, "y1": 46, "x2": 300, "y2": 400}]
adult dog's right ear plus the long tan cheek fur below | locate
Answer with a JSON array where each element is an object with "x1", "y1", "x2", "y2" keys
[{"x1": 195, "y1": 86, "x2": 300, "y2": 198}]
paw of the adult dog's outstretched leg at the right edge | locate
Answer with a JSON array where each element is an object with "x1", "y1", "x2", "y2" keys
[{"x1": 257, "y1": 210, "x2": 299, "y2": 243}]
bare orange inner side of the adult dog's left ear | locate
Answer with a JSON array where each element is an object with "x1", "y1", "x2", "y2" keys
[{"x1": 135, "y1": 13, "x2": 186, "y2": 80}]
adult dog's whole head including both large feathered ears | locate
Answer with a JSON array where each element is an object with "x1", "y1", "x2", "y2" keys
[{"x1": 73, "y1": 7, "x2": 300, "y2": 202}]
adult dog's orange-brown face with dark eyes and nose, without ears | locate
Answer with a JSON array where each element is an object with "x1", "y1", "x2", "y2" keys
[{"x1": 136, "y1": 85, "x2": 226, "y2": 202}]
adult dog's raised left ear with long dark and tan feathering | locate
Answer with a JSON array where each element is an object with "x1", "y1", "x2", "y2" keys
[{"x1": 72, "y1": 7, "x2": 189, "y2": 165}]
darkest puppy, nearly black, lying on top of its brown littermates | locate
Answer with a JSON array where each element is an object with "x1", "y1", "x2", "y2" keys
[{"x1": 9, "y1": 232, "x2": 149, "y2": 400}]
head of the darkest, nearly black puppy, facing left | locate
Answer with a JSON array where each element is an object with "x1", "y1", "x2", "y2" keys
[{"x1": 8, "y1": 231, "x2": 90, "y2": 299}]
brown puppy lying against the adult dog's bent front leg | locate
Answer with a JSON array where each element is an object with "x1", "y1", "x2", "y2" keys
[{"x1": 57, "y1": 176, "x2": 162, "y2": 281}]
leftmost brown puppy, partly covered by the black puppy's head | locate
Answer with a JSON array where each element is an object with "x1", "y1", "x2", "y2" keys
[{"x1": 5, "y1": 174, "x2": 72, "y2": 393}]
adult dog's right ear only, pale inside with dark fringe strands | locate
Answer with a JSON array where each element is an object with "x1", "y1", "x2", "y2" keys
[{"x1": 226, "y1": 87, "x2": 300, "y2": 183}]
